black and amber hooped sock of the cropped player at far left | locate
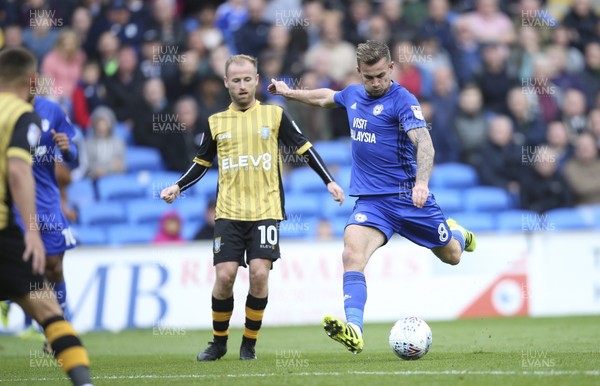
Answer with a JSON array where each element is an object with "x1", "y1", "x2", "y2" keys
[{"x1": 42, "y1": 316, "x2": 92, "y2": 385}]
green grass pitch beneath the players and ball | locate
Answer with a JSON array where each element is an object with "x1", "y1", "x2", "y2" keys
[{"x1": 0, "y1": 316, "x2": 600, "y2": 386}]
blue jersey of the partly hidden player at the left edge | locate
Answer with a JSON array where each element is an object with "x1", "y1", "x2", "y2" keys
[{"x1": 33, "y1": 96, "x2": 77, "y2": 212}]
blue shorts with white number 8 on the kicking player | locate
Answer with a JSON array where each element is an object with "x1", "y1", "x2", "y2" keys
[{"x1": 346, "y1": 193, "x2": 452, "y2": 249}]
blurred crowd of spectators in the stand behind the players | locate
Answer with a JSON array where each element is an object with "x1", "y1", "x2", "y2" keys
[{"x1": 0, "y1": 0, "x2": 600, "y2": 212}]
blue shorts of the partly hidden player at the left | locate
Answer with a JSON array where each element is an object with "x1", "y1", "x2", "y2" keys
[{"x1": 16, "y1": 208, "x2": 77, "y2": 256}]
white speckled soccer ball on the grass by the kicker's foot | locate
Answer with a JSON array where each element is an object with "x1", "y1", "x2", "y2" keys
[{"x1": 390, "y1": 316, "x2": 432, "y2": 361}]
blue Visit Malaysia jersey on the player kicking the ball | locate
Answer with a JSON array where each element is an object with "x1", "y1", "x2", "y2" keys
[{"x1": 334, "y1": 82, "x2": 427, "y2": 196}]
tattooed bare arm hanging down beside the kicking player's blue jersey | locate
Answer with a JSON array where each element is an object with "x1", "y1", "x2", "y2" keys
[{"x1": 407, "y1": 127, "x2": 435, "y2": 208}]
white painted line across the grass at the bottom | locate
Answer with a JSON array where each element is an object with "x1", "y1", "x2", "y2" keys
[{"x1": 0, "y1": 370, "x2": 600, "y2": 383}]
